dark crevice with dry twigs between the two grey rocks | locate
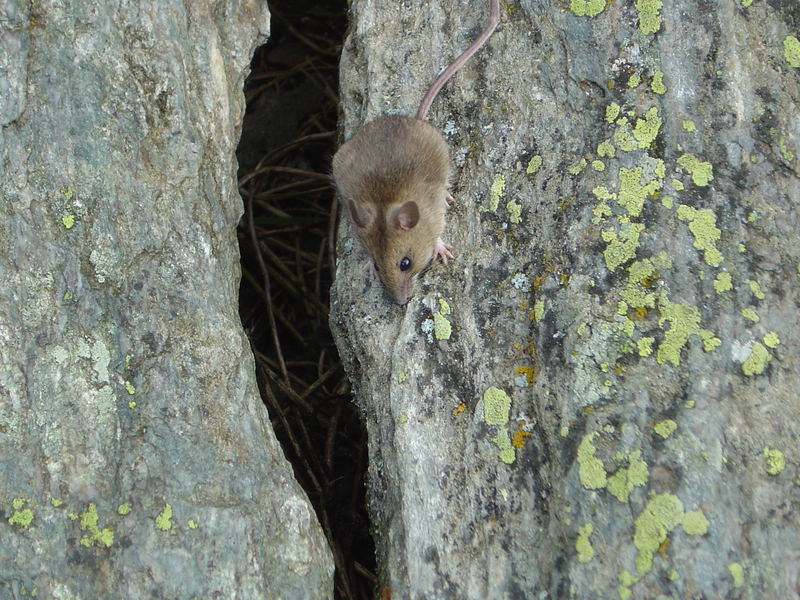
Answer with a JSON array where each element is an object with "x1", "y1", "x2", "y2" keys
[{"x1": 237, "y1": 0, "x2": 376, "y2": 599}]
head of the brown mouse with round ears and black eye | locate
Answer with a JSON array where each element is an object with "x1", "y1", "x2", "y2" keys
[{"x1": 347, "y1": 195, "x2": 442, "y2": 304}]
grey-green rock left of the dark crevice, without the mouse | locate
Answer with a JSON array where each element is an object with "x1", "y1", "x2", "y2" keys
[{"x1": 0, "y1": 0, "x2": 333, "y2": 600}]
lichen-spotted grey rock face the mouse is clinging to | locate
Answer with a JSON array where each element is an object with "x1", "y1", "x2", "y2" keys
[{"x1": 332, "y1": 0, "x2": 800, "y2": 599}]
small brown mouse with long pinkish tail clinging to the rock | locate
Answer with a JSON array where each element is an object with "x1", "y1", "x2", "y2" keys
[{"x1": 333, "y1": 0, "x2": 500, "y2": 304}]
